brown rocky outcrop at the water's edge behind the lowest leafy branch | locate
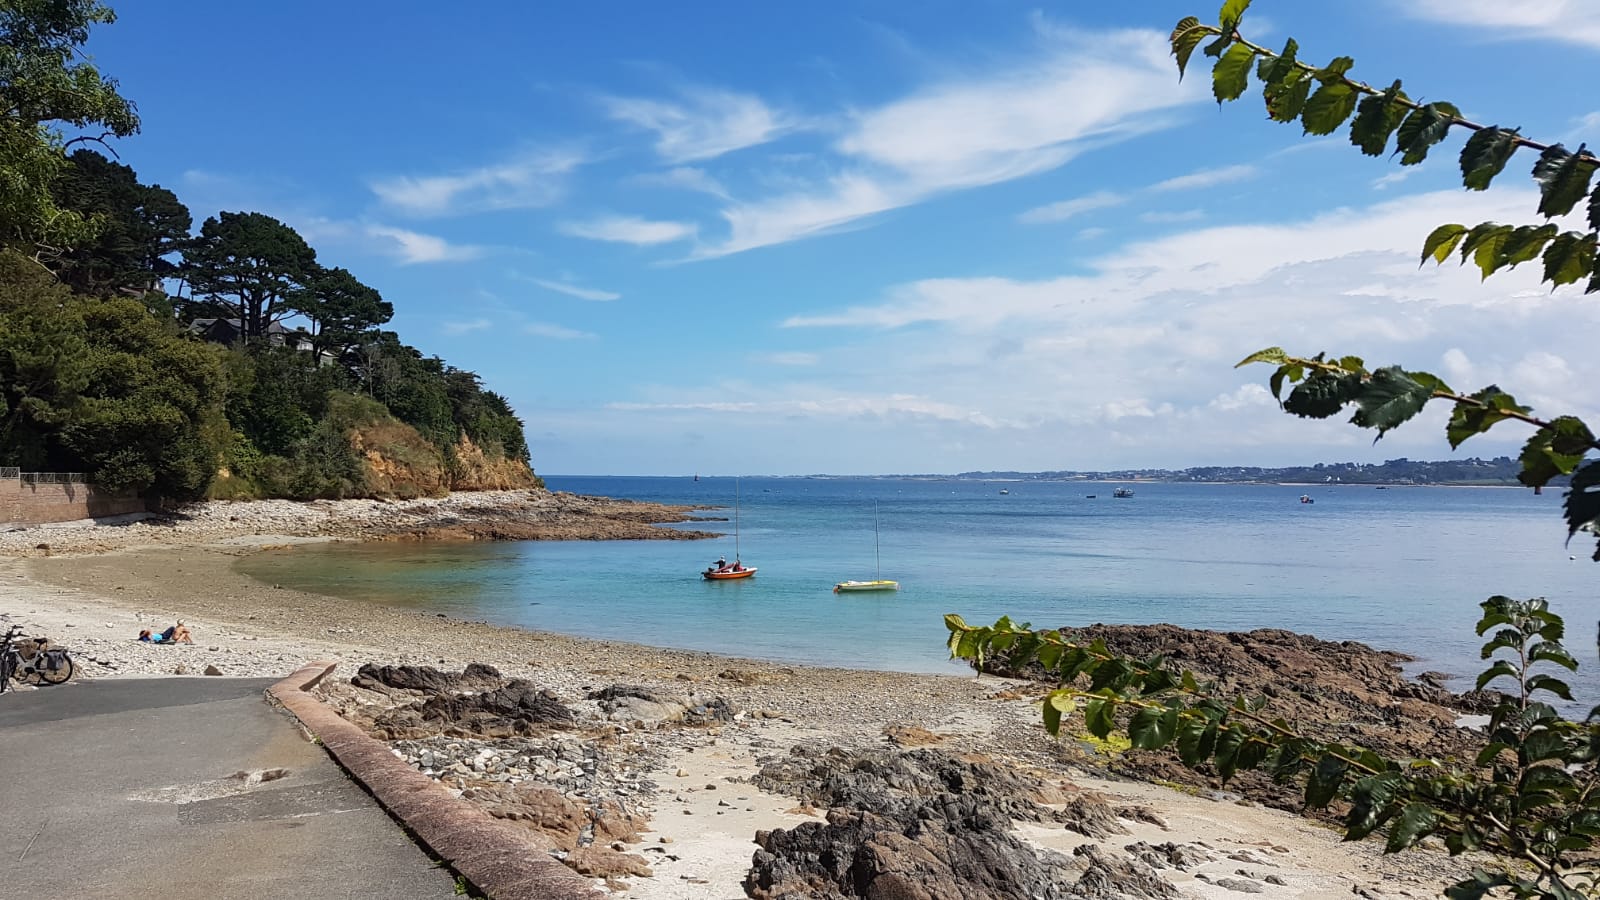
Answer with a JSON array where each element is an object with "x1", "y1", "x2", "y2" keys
[{"x1": 986, "y1": 625, "x2": 1496, "y2": 810}]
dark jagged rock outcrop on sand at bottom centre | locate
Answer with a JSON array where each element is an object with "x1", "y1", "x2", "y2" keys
[{"x1": 744, "y1": 748, "x2": 1176, "y2": 900}]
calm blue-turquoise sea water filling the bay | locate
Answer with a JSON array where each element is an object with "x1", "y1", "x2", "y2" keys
[{"x1": 242, "y1": 476, "x2": 1600, "y2": 698}]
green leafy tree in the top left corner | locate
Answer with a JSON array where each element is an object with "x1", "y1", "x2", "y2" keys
[{"x1": 0, "y1": 0, "x2": 139, "y2": 258}]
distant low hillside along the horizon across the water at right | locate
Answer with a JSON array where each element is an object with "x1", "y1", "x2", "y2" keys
[{"x1": 955, "y1": 456, "x2": 1522, "y2": 485}]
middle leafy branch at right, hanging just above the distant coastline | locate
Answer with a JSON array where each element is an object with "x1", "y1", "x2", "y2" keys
[{"x1": 1238, "y1": 348, "x2": 1600, "y2": 562}]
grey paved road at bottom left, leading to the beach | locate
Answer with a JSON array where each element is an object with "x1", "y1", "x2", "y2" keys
[{"x1": 0, "y1": 677, "x2": 454, "y2": 900}]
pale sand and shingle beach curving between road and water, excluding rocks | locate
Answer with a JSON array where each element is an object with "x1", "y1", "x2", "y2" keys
[{"x1": 0, "y1": 493, "x2": 1462, "y2": 898}]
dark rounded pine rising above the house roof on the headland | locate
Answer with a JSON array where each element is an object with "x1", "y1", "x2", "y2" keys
[{"x1": 182, "y1": 213, "x2": 317, "y2": 343}]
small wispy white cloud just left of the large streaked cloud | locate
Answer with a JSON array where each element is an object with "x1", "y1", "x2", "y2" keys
[{"x1": 602, "y1": 88, "x2": 792, "y2": 163}]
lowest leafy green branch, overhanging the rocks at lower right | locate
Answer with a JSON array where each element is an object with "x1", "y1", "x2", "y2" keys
[{"x1": 944, "y1": 596, "x2": 1600, "y2": 900}]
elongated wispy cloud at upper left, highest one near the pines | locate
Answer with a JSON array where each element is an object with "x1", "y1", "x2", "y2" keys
[{"x1": 370, "y1": 151, "x2": 586, "y2": 216}]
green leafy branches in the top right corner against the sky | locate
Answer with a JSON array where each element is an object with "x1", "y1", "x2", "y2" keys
[{"x1": 1170, "y1": 0, "x2": 1600, "y2": 293}]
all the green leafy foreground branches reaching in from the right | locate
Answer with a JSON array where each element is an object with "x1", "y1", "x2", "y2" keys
[{"x1": 946, "y1": 0, "x2": 1600, "y2": 900}]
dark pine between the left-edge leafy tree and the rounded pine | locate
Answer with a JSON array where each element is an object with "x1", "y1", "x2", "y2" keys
[{"x1": 51, "y1": 151, "x2": 194, "y2": 295}]
